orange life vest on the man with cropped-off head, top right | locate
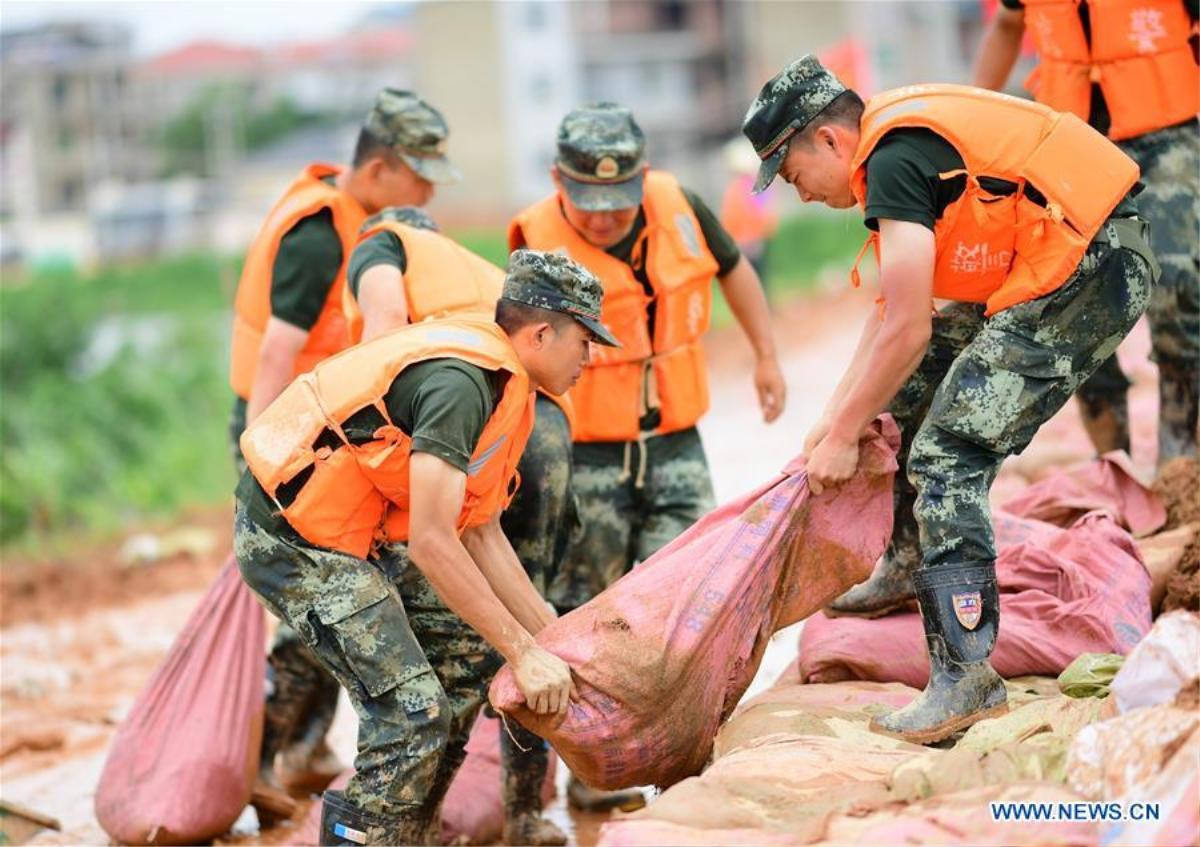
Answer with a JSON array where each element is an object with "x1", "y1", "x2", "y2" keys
[{"x1": 1025, "y1": 0, "x2": 1200, "y2": 140}]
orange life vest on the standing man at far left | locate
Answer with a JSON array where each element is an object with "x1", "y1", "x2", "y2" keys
[{"x1": 229, "y1": 164, "x2": 367, "y2": 400}]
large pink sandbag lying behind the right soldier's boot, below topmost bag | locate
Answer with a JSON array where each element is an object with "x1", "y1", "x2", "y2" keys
[{"x1": 797, "y1": 512, "x2": 1151, "y2": 689}]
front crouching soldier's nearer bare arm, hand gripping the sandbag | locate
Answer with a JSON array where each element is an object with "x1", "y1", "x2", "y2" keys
[{"x1": 408, "y1": 452, "x2": 571, "y2": 714}]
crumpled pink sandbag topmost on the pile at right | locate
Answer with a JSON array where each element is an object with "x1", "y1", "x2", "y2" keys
[{"x1": 1001, "y1": 451, "x2": 1166, "y2": 536}]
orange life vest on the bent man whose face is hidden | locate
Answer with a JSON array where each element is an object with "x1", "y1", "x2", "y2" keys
[{"x1": 342, "y1": 221, "x2": 575, "y2": 426}]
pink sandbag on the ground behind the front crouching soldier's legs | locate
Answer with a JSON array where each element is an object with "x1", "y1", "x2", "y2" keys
[{"x1": 442, "y1": 714, "x2": 558, "y2": 845}]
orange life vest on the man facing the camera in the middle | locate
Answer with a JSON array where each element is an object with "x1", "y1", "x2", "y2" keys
[{"x1": 509, "y1": 170, "x2": 718, "y2": 441}]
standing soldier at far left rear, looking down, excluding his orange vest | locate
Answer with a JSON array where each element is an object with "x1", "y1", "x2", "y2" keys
[{"x1": 229, "y1": 89, "x2": 458, "y2": 792}]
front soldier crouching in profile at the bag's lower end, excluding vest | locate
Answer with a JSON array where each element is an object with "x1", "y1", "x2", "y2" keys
[{"x1": 234, "y1": 251, "x2": 616, "y2": 845}]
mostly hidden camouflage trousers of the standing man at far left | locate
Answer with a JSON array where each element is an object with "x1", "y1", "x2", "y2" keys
[{"x1": 229, "y1": 388, "x2": 337, "y2": 773}]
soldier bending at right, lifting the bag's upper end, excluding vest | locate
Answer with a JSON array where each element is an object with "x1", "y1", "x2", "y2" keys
[{"x1": 743, "y1": 56, "x2": 1158, "y2": 743}]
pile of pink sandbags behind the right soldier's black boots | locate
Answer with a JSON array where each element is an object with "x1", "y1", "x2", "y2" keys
[{"x1": 791, "y1": 453, "x2": 1165, "y2": 687}]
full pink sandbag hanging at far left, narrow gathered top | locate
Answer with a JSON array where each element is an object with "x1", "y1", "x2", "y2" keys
[{"x1": 95, "y1": 555, "x2": 266, "y2": 845}]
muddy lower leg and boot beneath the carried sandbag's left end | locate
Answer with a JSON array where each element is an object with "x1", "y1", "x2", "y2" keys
[{"x1": 500, "y1": 721, "x2": 566, "y2": 847}]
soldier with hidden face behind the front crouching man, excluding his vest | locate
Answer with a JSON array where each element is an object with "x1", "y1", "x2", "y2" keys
[{"x1": 346, "y1": 206, "x2": 578, "y2": 847}]
